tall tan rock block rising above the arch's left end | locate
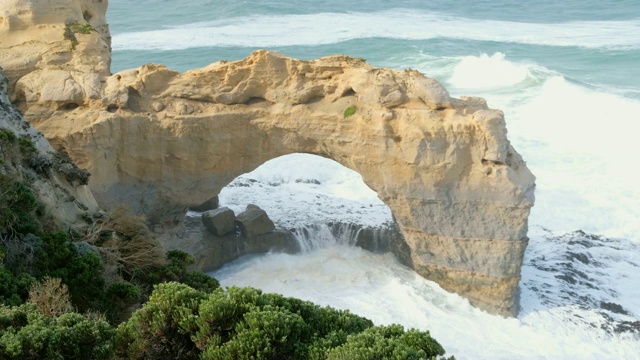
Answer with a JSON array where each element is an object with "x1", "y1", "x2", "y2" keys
[{"x1": 0, "y1": 0, "x2": 111, "y2": 93}]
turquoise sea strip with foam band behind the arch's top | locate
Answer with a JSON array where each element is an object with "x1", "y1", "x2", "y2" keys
[{"x1": 109, "y1": 0, "x2": 640, "y2": 96}]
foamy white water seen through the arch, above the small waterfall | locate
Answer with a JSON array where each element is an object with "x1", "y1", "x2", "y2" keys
[{"x1": 220, "y1": 154, "x2": 392, "y2": 228}]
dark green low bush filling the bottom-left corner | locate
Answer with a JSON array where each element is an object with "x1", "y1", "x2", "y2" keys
[{"x1": 0, "y1": 304, "x2": 114, "y2": 360}]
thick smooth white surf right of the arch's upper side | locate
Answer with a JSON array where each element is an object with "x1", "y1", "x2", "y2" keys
[{"x1": 504, "y1": 77, "x2": 640, "y2": 241}]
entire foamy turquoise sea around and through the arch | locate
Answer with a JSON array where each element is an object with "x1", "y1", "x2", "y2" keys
[{"x1": 107, "y1": 0, "x2": 640, "y2": 359}]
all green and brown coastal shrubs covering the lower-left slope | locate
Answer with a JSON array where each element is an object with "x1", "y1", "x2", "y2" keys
[{"x1": 0, "y1": 121, "x2": 452, "y2": 359}]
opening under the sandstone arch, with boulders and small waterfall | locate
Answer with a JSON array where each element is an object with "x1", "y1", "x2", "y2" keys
[{"x1": 180, "y1": 153, "x2": 409, "y2": 270}]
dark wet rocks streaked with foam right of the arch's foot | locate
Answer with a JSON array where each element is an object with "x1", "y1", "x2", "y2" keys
[{"x1": 520, "y1": 229, "x2": 640, "y2": 337}]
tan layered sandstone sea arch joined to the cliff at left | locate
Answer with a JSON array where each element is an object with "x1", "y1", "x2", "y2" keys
[{"x1": 0, "y1": 0, "x2": 535, "y2": 315}]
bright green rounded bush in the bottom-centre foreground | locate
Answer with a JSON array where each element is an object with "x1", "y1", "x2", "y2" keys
[{"x1": 116, "y1": 283, "x2": 444, "y2": 360}]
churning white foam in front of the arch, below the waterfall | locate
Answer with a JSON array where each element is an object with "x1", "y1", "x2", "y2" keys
[{"x1": 212, "y1": 226, "x2": 640, "y2": 359}]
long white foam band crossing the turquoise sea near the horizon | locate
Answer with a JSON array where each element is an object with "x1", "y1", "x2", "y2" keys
[{"x1": 113, "y1": 9, "x2": 640, "y2": 51}]
